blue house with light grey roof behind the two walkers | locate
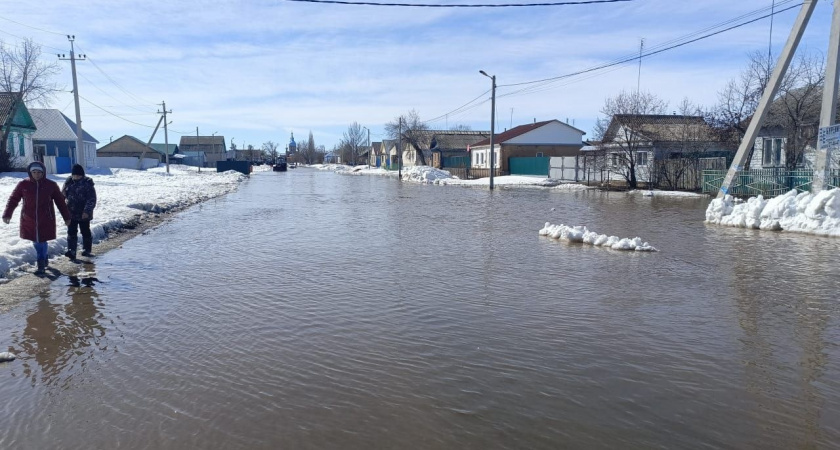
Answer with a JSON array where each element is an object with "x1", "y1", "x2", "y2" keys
[{"x1": 29, "y1": 108, "x2": 99, "y2": 173}]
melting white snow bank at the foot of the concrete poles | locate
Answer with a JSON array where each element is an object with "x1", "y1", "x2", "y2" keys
[{"x1": 706, "y1": 189, "x2": 840, "y2": 236}]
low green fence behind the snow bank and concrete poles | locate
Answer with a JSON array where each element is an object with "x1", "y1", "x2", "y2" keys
[{"x1": 703, "y1": 169, "x2": 840, "y2": 198}]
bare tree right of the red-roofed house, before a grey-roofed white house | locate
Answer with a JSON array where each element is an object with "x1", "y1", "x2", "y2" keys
[{"x1": 595, "y1": 91, "x2": 668, "y2": 189}]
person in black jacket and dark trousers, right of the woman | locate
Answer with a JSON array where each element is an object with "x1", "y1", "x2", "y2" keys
[{"x1": 61, "y1": 164, "x2": 96, "y2": 259}]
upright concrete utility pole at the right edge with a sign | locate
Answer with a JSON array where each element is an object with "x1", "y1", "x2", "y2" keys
[{"x1": 811, "y1": 0, "x2": 840, "y2": 194}]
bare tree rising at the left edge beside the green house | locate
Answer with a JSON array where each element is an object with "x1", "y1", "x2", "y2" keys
[{"x1": 0, "y1": 39, "x2": 60, "y2": 171}]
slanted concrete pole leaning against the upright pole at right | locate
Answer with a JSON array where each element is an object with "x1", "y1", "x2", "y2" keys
[{"x1": 717, "y1": 0, "x2": 820, "y2": 198}]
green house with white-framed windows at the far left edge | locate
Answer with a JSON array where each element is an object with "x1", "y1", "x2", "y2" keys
[{"x1": 0, "y1": 92, "x2": 37, "y2": 168}]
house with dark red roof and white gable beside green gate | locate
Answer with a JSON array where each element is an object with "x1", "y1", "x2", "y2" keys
[{"x1": 470, "y1": 119, "x2": 586, "y2": 175}]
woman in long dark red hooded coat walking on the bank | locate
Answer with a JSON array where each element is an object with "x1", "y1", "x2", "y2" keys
[{"x1": 3, "y1": 162, "x2": 70, "y2": 274}]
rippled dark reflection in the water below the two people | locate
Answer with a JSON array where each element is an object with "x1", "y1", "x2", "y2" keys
[{"x1": 14, "y1": 273, "x2": 108, "y2": 386}]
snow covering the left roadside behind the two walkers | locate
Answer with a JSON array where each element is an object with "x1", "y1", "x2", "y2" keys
[{"x1": 0, "y1": 166, "x2": 248, "y2": 280}]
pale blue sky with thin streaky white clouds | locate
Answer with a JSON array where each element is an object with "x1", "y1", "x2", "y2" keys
[{"x1": 0, "y1": 0, "x2": 832, "y2": 149}]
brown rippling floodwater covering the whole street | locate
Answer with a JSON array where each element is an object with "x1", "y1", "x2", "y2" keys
[{"x1": 0, "y1": 169, "x2": 840, "y2": 449}]
